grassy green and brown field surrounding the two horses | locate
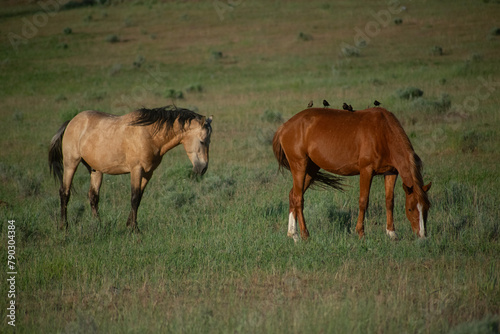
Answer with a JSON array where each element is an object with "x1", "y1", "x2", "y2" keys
[{"x1": 0, "y1": 0, "x2": 500, "y2": 333}]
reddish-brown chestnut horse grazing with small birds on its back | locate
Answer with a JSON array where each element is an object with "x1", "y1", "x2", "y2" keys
[{"x1": 273, "y1": 107, "x2": 431, "y2": 241}]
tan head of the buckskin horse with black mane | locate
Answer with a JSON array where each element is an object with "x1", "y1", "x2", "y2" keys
[{"x1": 182, "y1": 116, "x2": 212, "y2": 175}]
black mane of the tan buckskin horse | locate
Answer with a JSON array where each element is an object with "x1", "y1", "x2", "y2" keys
[{"x1": 130, "y1": 105, "x2": 203, "y2": 133}]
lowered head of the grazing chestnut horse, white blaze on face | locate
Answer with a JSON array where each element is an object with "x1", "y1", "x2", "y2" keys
[{"x1": 403, "y1": 182, "x2": 432, "y2": 238}]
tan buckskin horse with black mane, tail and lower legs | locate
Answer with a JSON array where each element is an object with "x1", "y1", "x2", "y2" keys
[{"x1": 49, "y1": 106, "x2": 212, "y2": 232}]
